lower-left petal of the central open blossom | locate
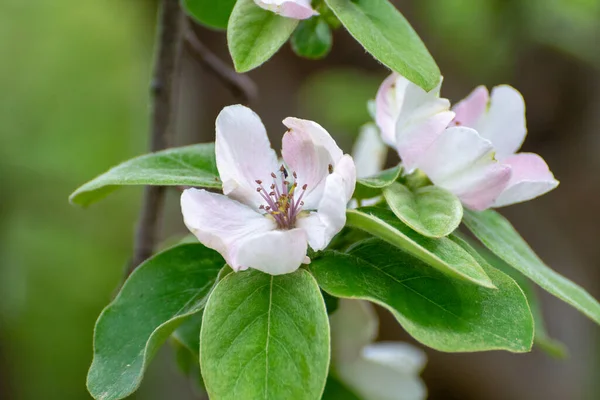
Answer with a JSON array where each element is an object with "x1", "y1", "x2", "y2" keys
[{"x1": 181, "y1": 189, "x2": 277, "y2": 271}]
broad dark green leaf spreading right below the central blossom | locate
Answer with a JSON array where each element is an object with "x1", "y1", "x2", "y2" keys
[{"x1": 310, "y1": 238, "x2": 533, "y2": 353}]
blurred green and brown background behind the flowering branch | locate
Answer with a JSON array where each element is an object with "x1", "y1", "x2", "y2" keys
[{"x1": 0, "y1": 0, "x2": 600, "y2": 400}]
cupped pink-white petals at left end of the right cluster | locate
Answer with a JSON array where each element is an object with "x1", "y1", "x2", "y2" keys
[{"x1": 375, "y1": 73, "x2": 454, "y2": 172}]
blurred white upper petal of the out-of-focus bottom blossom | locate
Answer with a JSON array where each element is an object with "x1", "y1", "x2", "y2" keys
[{"x1": 362, "y1": 342, "x2": 427, "y2": 375}]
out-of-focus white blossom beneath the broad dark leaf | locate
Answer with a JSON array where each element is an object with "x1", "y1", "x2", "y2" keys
[{"x1": 330, "y1": 299, "x2": 427, "y2": 400}]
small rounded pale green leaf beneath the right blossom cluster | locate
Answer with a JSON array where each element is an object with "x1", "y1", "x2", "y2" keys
[{"x1": 383, "y1": 182, "x2": 463, "y2": 238}]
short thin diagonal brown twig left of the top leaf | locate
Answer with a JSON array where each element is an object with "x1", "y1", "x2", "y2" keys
[{"x1": 185, "y1": 23, "x2": 258, "y2": 105}]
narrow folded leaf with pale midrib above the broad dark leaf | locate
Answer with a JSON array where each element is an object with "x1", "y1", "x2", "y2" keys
[{"x1": 346, "y1": 207, "x2": 494, "y2": 288}]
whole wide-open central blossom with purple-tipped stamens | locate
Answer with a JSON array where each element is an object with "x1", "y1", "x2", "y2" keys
[{"x1": 181, "y1": 105, "x2": 356, "y2": 275}]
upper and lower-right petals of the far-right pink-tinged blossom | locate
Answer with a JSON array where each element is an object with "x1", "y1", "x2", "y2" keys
[{"x1": 453, "y1": 85, "x2": 559, "y2": 207}]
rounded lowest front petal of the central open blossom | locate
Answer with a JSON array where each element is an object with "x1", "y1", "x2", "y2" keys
[{"x1": 236, "y1": 228, "x2": 308, "y2": 275}]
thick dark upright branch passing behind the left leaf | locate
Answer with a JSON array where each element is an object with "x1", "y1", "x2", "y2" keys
[{"x1": 126, "y1": 0, "x2": 184, "y2": 275}]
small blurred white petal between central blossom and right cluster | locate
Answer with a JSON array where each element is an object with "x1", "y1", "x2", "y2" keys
[{"x1": 352, "y1": 123, "x2": 387, "y2": 178}]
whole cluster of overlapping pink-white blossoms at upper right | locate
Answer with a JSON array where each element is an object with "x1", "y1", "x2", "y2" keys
[{"x1": 375, "y1": 74, "x2": 558, "y2": 210}]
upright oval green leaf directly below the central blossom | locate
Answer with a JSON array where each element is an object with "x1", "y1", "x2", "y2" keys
[{"x1": 200, "y1": 269, "x2": 330, "y2": 400}]
